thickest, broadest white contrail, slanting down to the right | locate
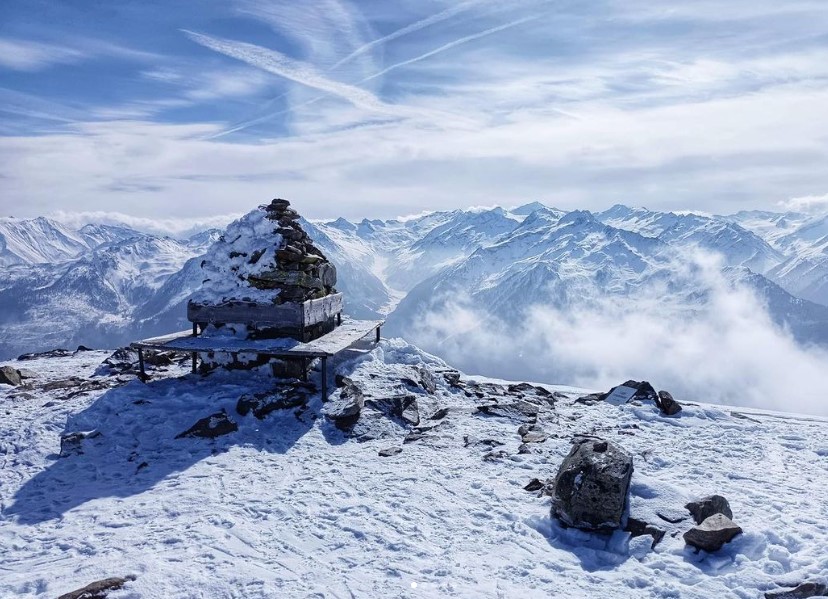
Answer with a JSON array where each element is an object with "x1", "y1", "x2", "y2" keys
[{"x1": 182, "y1": 29, "x2": 411, "y2": 116}]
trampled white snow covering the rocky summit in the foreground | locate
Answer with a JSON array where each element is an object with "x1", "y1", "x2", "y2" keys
[{"x1": 0, "y1": 340, "x2": 828, "y2": 599}]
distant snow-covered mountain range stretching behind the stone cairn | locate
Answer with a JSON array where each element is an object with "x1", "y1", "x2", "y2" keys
[{"x1": 0, "y1": 202, "x2": 828, "y2": 367}]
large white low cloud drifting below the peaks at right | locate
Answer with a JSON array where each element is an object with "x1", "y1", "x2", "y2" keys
[{"x1": 407, "y1": 252, "x2": 828, "y2": 415}]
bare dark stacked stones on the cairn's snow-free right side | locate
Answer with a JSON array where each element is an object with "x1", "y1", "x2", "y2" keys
[{"x1": 247, "y1": 199, "x2": 336, "y2": 303}]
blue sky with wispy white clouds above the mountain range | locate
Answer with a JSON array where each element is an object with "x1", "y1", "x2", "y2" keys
[{"x1": 0, "y1": 0, "x2": 828, "y2": 219}]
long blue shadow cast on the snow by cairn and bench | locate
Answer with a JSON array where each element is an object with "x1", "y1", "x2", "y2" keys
[{"x1": 3, "y1": 371, "x2": 322, "y2": 524}]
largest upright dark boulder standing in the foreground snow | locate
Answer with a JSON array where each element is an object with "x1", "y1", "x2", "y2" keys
[{"x1": 552, "y1": 437, "x2": 633, "y2": 531}]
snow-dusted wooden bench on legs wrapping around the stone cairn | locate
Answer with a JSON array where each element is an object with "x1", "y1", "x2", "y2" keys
[{"x1": 130, "y1": 319, "x2": 385, "y2": 400}]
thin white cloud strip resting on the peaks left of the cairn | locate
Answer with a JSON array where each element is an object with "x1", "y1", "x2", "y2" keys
[{"x1": 49, "y1": 210, "x2": 242, "y2": 238}]
